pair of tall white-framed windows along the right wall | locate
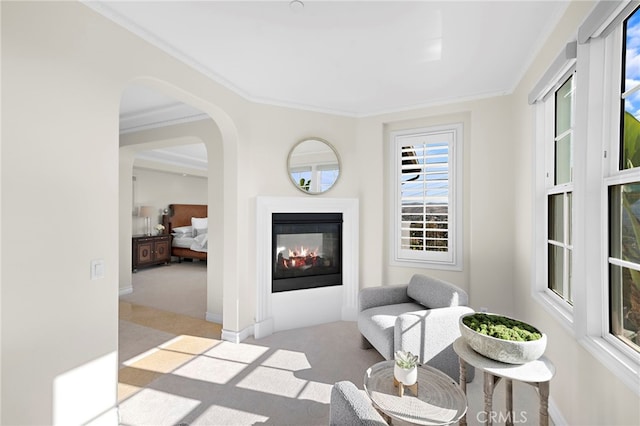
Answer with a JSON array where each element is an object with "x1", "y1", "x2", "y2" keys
[{"x1": 529, "y1": 1, "x2": 640, "y2": 393}]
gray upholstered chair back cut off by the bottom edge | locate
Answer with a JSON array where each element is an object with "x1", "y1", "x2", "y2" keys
[{"x1": 329, "y1": 381, "x2": 388, "y2": 426}]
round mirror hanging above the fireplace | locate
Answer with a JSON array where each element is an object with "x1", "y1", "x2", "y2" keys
[{"x1": 287, "y1": 138, "x2": 340, "y2": 194}]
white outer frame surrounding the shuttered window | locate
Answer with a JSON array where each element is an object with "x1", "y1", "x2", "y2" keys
[{"x1": 388, "y1": 122, "x2": 464, "y2": 271}]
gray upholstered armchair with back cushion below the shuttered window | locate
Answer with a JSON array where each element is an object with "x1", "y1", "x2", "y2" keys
[{"x1": 358, "y1": 274, "x2": 474, "y2": 382}]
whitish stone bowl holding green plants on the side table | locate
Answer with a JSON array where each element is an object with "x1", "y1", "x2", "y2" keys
[{"x1": 459, "y1": 312, "x2": 547, "y2": 364}]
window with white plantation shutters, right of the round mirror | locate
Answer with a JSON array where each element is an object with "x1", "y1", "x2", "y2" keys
[{"x1": 391, "y1": 125, "x2": 462, "y2": 268}]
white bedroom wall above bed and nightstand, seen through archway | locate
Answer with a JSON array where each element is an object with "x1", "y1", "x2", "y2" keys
[{"x1": 133, "y1": 166, "x2": 208, "y2": 235}]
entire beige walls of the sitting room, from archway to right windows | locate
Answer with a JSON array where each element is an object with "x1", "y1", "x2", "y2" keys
[{"x1": 0, "y1": 2, "x2": 639, "y2": 424}]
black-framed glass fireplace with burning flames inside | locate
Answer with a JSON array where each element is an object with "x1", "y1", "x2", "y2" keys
[{"x1": 272, "y1": 213, "x2": 342, "y2": 293}]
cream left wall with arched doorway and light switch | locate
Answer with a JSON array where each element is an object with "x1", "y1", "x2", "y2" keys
[{"x1": 0, "y1": 2, "x2": 246, "y2": 424}]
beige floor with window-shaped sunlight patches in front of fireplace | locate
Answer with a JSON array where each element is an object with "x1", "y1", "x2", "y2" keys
[{"x1": 118, "y1": 264, "x2": 538, "y2": 426}]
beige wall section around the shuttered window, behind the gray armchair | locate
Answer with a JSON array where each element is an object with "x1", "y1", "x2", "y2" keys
[{"x1": 358, "y1": 96, "x2": 515, "y2": 313}]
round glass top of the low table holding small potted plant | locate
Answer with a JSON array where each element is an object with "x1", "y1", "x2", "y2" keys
[{"x1": 364, "y1": 361, "x2": 467, "y2": 425}]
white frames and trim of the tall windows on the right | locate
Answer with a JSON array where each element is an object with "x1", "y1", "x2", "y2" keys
[{"x1": 529, "y1": 3, "x2": 640, "y2": 395}]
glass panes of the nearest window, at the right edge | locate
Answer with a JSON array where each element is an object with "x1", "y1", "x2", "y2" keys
[{"x1": 606, "y1": 10, "x2": 640, "y2": 352}]
